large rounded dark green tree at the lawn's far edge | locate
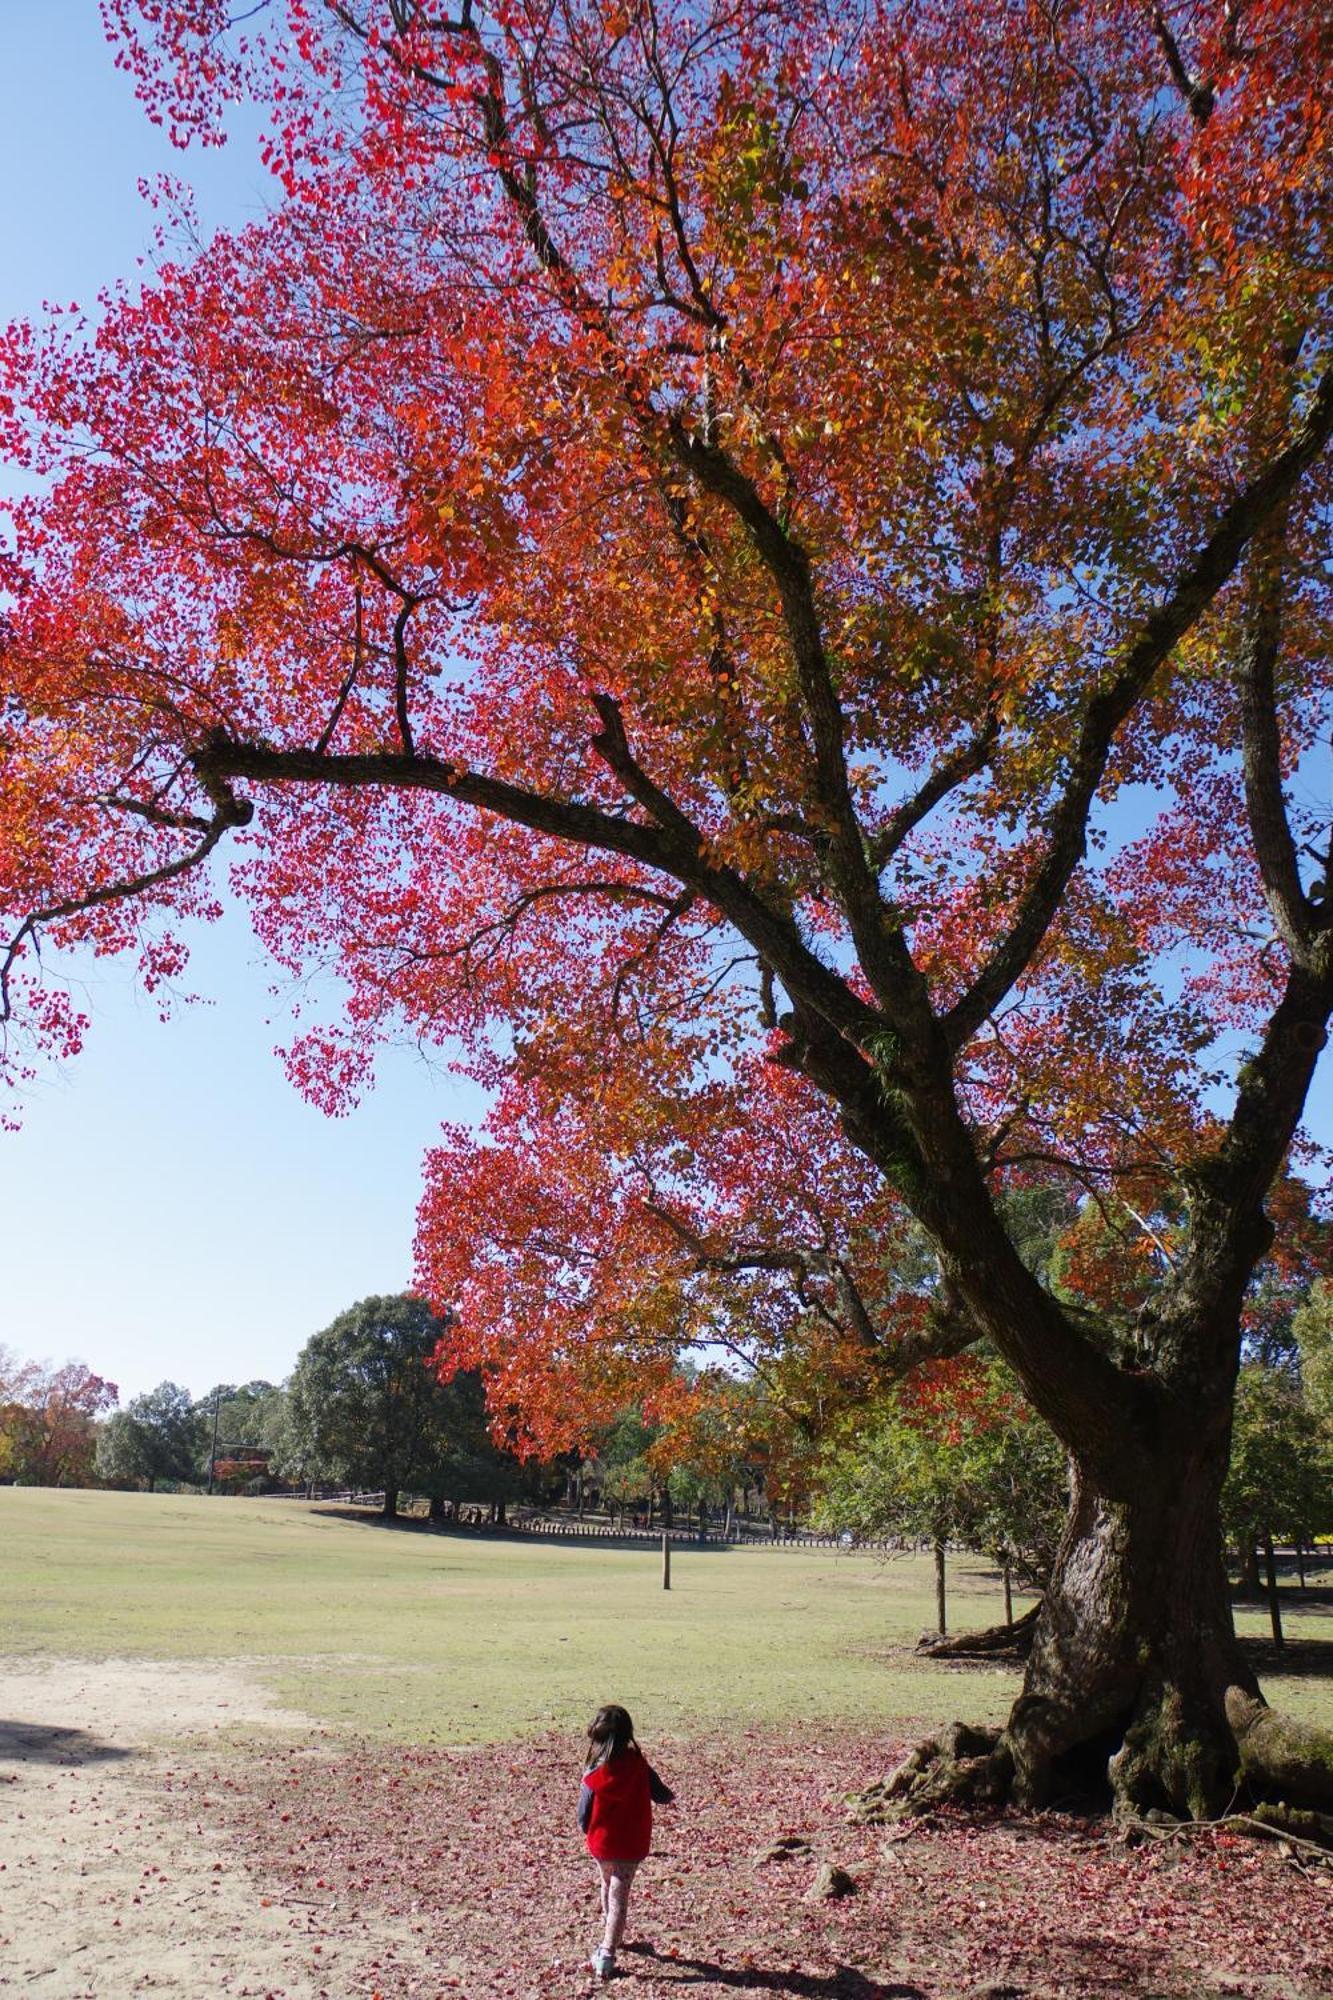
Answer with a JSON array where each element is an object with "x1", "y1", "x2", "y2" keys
[{"x1": 280, "y1": 1294, "x2": 526, "y2": 1518}]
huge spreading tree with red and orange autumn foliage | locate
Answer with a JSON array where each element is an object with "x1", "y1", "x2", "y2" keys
[{"x1": 0, "y1": 0, "x2": 1333, "y2": 1814}]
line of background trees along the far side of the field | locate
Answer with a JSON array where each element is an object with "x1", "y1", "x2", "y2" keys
[{"x1": 0, "y1": 1272, "x2": 1333, "y2": 1646}]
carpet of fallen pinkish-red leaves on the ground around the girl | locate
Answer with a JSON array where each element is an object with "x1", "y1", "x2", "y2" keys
[{"x1": 186, "y1": 1728, "x2": 1333, "y2": 2000}]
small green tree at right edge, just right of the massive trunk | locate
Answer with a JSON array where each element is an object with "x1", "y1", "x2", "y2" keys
[{"x1": 1223, "y1": 1362, "x2": 1333, "y2": 1648}]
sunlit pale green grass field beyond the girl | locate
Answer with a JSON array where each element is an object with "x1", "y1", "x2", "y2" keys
[{"x1": 0, "y1": 1488, "x2": 1333, "y2": 1744}]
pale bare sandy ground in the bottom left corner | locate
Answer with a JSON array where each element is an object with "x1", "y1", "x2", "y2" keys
[{"x1": 0, "y1": 1660, "x2": 446, "y2": 2000}]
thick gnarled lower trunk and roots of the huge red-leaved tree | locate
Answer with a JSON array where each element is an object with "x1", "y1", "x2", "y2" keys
[{"x1": 867, "y1": 1436, "x2": 1333, "y2": 1820}]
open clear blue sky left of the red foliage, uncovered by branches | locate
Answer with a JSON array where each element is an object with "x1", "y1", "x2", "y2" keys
[{"x1": 0, "y1": 11, "x2": 1333, "y2": 1400}]
